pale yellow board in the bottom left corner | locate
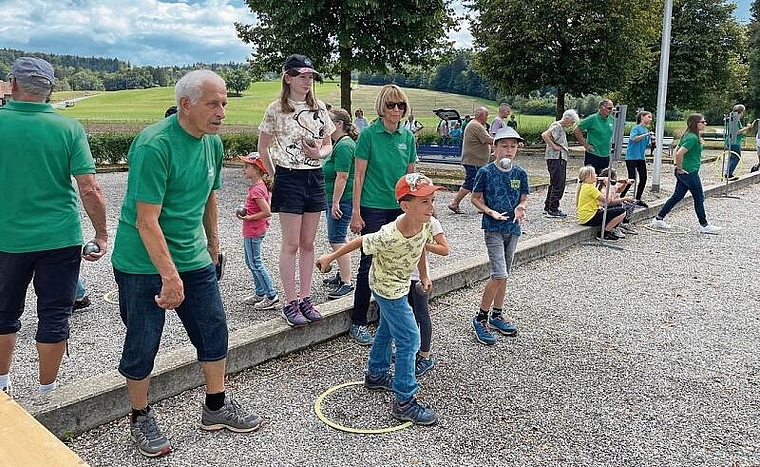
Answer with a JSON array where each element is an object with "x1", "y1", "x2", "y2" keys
[{"x1": 0, "y1": 391, "x2": 87, "y2": 467}]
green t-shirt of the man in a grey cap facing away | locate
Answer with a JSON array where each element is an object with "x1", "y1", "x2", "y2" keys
[{"x1": 0, "y1": 101, "x2": 95, "y2": 253}]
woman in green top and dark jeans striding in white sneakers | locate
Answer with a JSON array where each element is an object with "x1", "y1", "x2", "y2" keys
[{"x1": 652, "y1": 114, "x2": 721, "y2": 235}]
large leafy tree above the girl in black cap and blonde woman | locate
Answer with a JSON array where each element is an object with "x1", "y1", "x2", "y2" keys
[{"x1": 235, "y1": 0, "x2": 456, "y2": 113}]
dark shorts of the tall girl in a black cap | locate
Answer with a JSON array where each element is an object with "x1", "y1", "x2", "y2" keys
[{"x1": 272, "y1": 165, "x2": 327, "y2": 214}]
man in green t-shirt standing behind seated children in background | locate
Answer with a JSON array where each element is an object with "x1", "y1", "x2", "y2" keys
[{"x1": 573, "y1": 99, "x2": 615, "y2": 175}]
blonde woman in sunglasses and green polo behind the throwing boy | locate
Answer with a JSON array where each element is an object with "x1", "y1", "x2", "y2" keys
[{"x1": 349, "y1": 84, "x2": 417, "y2": 345}]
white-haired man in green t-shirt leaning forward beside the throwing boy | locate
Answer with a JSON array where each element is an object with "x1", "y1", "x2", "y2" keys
[{"x1": 111, "y1": 70, "x2": 262, "y2": 457}]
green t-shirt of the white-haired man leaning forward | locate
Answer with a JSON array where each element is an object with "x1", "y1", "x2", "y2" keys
[{"x1": 111, "y1": 115, "x2": 224, "y2": 274}]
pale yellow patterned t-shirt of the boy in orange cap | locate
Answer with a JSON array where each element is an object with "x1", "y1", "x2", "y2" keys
[{"x1": 362, "y1": 217, "x2": 433, "y2": 300}]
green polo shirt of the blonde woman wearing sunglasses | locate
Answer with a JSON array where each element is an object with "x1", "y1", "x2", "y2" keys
[{"x1": 354, "y1": 118, "x2": 417, "y2": 209}]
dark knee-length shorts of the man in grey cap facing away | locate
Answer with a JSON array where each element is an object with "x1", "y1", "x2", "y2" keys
[{"x1": 0, "y1": 245, "x2": 82, "y2": 344}]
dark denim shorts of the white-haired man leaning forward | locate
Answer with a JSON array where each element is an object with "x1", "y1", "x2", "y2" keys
[{"x1": 113, "y1": 264, "x2": 228, "y2": 381}]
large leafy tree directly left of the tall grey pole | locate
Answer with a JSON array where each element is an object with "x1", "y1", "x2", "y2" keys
[{"x1": 469, "y1": 0, "x2": 661, "y2": 118}]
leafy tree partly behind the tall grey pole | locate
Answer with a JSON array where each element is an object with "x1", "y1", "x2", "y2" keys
[{"x1": 623, "y1": 0, "x2": 747, "y2": 116}]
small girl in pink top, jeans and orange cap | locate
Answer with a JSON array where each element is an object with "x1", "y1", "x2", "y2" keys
[{"x1": 236, "y1": 152, "x2": 280, "y2": 310}]
